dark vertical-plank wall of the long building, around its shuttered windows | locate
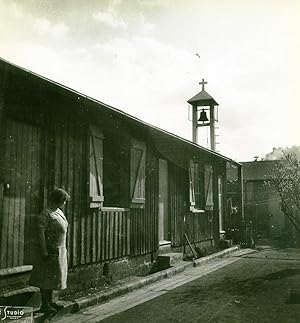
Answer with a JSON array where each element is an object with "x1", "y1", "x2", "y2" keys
[{"x1": 0, "y1": 59, "x2": 232, "y2": 278}]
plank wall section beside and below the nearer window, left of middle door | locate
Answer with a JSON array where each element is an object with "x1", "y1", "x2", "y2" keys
[{"x1": 51, "y1": 117, "x2": 158, "y2": 267}]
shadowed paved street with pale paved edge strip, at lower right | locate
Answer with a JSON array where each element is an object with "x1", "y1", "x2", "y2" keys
[{"x1": 57, "y1": 249, "x2": 300, "y2": 323}]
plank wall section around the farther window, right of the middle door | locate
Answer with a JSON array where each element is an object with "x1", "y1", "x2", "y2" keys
[{"x1": 169, "y1": 158, "x2": 225, "y2": 247}]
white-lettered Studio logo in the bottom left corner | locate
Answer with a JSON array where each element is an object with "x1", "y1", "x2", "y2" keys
[{"x1": 0, "y1": 306, "x2": 33, "y2": 323}]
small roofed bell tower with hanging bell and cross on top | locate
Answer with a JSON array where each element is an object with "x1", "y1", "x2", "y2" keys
[{"x1": 187, "y1": 79, "x2": 218, "y2": 151}]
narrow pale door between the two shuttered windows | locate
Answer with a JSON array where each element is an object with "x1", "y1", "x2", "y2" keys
[{"x1": 158, "y1": 159, "x2": 169, "y2": 241}]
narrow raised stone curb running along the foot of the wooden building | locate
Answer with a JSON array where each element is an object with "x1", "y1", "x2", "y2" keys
[{"x1": 61, "y1": 246, "x2": 239, "y2": 314}]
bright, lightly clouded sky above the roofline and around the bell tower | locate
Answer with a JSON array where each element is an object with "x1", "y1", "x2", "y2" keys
[{"x1": 0, "y1": 0, "x2": 300, "y2": 161}]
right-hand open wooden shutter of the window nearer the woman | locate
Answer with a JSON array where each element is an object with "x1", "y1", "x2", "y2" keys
[{"x1": 130, "y1": 141, "x2": 146, "y2": 204}]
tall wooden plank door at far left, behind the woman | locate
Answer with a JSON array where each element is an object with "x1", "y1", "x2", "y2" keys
[{"x1": 0, "y1": 119, "x2": 42, "y2": 268}]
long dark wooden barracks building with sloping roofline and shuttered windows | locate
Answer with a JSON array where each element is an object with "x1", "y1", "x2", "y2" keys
[{"x1": 0, "y1": 59, "x2": 242, "y2": 306}]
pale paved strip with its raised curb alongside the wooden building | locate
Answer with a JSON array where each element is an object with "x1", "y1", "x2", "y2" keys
[{"x1": 37, "y1": 247, "x2": 255, "y2": 323}]
